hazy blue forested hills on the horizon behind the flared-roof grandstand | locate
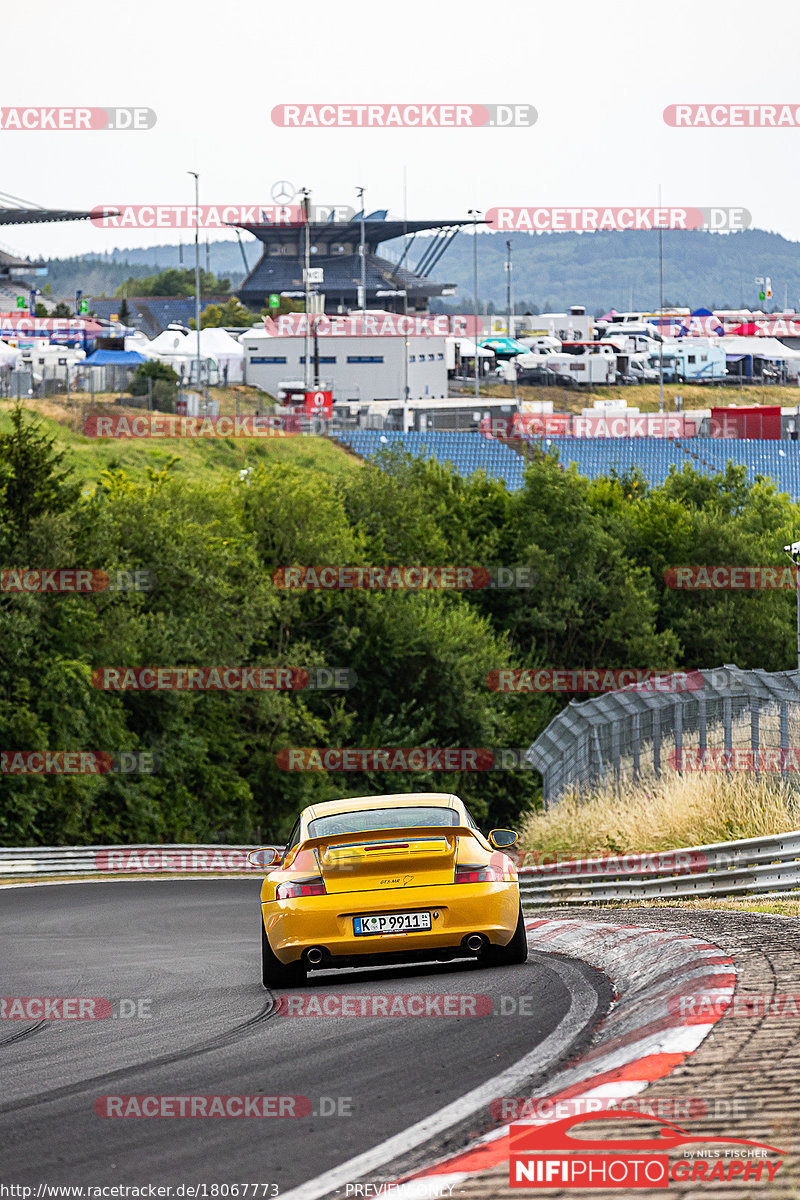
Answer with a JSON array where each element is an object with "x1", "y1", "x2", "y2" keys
[{"x1": 34, "y1": 229, "x2": 800, "y2": 313}]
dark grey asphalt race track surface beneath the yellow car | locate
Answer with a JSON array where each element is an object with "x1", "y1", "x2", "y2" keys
[{"x1": 0, "y1": 880, "x2": 609, "y2": 1196}]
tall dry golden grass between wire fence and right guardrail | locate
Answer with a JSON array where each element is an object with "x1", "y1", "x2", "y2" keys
[{"x1": 519, "y1": 772, "x2": 800, "y2": 858}]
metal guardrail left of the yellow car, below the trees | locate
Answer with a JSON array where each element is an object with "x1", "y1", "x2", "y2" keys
[{"x1": 0, "y1": 844, "x2": 275, "y2": 882}]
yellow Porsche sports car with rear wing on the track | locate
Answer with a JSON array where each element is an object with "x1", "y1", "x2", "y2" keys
[{"x1": 249, "y1": 792, "x2": 528, "y2": 988}]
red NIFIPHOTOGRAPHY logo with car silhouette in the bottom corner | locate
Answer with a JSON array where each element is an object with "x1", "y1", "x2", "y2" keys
[{"x1": 509, "y1": 1110, "x2": 784, "y2": 1189}]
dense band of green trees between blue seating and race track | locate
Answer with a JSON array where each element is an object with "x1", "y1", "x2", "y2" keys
[{"x1": 0, "y1": 409, "x2": 800, "y2": 845}]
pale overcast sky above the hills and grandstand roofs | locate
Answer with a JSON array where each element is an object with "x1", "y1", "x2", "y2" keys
[{"x1": 0, "y1": 0, "x2": 800, "y2": 257}]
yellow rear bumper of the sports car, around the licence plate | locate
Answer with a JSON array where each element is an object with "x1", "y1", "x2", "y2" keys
[{"x1": 261, "y1": 883, "x2": 519, "y2": 966}]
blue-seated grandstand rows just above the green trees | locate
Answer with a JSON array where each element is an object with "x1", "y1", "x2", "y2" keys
[{"x1": 336, "y1": 430, "x2": 800, "y2": 500}]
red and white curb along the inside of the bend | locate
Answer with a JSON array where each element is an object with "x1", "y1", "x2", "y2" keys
[{"x1": 391, "y1": 918, "x2": 735, "y2": 1200}]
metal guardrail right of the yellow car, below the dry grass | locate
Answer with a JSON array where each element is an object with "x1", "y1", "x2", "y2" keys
[{"x1": 519, "y1": 830, "x2": 800, "y2": 907}]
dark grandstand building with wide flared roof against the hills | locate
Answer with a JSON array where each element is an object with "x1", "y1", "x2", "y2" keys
[{"x1": 230, "y1": 210, "x2": 481, "y2": 312}]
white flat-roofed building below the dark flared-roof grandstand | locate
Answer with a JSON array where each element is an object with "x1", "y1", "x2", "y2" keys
[{"x1": 240, "y1": 329, "x2": 447, "y2": 404}]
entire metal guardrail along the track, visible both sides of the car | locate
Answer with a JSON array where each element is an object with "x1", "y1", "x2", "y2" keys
[{"x1": 0, "y1": 830, "x2": 800, "y2": 907}]
